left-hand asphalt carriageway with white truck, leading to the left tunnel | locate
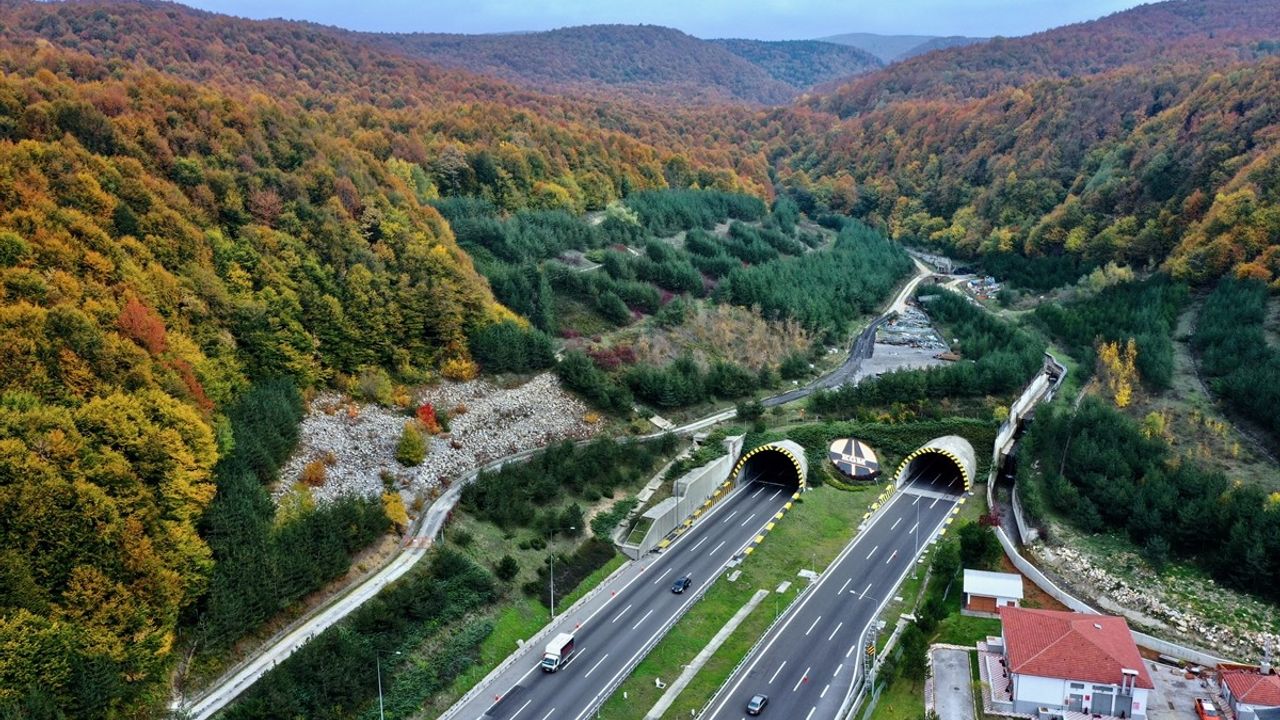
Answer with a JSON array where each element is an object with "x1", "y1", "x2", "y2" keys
[{"x1": 478, "y1": 471, "x2": 795, "y2": 720}]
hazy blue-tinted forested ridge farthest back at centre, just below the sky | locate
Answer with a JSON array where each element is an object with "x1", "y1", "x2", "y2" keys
[{"x1": 351, "y1": 24, "x2": 881, "y2": 105}]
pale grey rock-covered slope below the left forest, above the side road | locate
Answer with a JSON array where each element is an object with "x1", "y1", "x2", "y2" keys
[{"x1": 275, "y1": 373, "x2": 595, "y2": 502}]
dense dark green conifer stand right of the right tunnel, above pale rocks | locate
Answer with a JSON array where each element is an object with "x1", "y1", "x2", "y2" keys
[{"x1": 1018, "y1": 396, "x2": 1280, "y2": 602}]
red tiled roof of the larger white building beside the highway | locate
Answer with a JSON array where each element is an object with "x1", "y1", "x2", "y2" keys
[{"x1": 1000, "y1": 607, "x2": 1155, "y2": 689}]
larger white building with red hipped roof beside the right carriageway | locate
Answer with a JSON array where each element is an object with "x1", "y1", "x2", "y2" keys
[{"x1": 998, "y1": 607, "x2": 1155, "y2": 720}]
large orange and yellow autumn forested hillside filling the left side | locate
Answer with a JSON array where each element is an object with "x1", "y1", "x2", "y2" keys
[{"x1": 0, "y1": 1, "x2": 763, "y2": 717}]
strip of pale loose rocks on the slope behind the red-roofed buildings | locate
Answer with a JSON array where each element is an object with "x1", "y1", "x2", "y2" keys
[{"x1": 1036, "y1": 546, "x2": 1280, "y2": 661}]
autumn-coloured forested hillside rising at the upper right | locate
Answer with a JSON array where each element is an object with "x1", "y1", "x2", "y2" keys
[{"x1": 762, "y1": 0, "x2": 1280, "y2": 282}]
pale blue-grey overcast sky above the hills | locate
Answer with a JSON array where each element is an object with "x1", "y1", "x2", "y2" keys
[{"x1": 184, "y1": 0, "x2": 1139, "y2": 40}]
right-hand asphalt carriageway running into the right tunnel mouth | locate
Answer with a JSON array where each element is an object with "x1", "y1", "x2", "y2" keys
[{"x1": 704, "y1": 460, "x2": 964, "y2": 720}]
